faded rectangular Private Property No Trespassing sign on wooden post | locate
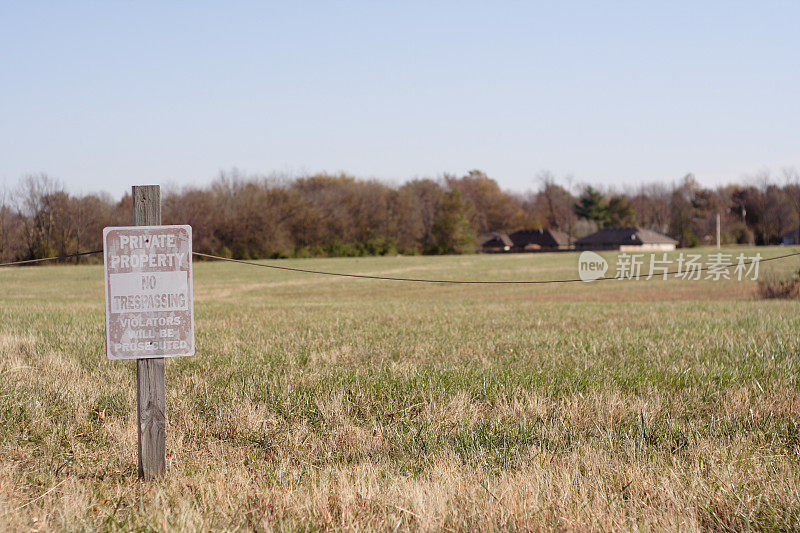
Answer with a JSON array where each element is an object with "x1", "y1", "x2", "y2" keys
[{"x1": 103, "y1": 222, "x2": 194, "y2": 359}]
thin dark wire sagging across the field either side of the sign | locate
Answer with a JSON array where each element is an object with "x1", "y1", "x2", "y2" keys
[{"x1": 0, "y1": 250, "x2": 800, "y2": 285}]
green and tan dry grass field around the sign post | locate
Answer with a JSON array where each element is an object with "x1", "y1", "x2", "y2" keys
[{"x1": 0, "y1": 248, "x2": 800, "y2": 531}]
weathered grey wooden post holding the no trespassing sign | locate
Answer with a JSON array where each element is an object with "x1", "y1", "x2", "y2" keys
[{"x1": 132, "y1": 185, "x2": 167, "y2": 480}]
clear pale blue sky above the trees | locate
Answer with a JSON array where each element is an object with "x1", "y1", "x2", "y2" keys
[{"x1": 0, "y1": 1, "x2": 800, "y2": 196}]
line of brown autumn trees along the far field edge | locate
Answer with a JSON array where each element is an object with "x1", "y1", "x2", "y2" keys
[{"x1": 0, "y1": 169, "x2": 800, "y2": 262}]
